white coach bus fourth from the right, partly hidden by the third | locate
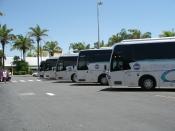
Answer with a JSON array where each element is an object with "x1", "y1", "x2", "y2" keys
[{"x1": 43, "y1": 57, "x2": 58, "y2": 79}]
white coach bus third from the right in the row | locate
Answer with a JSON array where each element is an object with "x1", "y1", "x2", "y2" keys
[{"x1": 55, "y1": 55, "x2": 78, "y2": 82}]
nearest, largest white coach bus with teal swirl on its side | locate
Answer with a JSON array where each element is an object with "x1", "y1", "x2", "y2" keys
[{"x1": 107, "y1": 37, "x2": 175, "y2": 90}]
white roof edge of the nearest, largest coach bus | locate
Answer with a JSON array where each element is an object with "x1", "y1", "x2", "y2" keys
[{"x1": 114, "y1": 37, "x2": 175, "y2": 46}]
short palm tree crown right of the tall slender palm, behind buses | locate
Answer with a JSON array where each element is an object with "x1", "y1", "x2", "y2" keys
[{"x1": 43, "y1": 41, "x2": 62, "y2": 56}]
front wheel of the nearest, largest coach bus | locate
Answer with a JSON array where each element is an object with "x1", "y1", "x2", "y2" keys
[{"x1": 139, "y1": 75, "x2": 156, "y2": 91}]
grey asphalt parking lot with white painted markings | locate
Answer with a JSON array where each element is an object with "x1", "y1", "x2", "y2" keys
[{"x1": 0, "y1": 76, "x2": 175, "y2": 131}]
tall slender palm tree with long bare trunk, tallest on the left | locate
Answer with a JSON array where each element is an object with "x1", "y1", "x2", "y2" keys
[{"x1": 29, "y1": 25, "x2": 48, "y2": 70}]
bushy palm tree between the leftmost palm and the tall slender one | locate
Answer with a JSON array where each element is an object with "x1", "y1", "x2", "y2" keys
[{"x1": 12, "y1": 35, "x2": 33, "y2": 61}]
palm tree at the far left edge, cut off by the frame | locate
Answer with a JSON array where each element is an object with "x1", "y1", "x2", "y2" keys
[{"x1": 0, "y1": 24, "x2": 15, "y2": 69}]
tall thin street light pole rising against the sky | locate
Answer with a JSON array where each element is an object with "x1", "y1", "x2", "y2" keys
[{"x1": 97, "y1": 0, "x2": 103, "y2": 49}]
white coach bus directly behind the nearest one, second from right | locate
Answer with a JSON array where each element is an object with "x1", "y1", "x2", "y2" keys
[{"x1": 76, "y1": 49, "x2": 112, "y2": 85}]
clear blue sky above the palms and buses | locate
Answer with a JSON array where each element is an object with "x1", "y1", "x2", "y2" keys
[{"x1": 0, "y1": 0, "x2": 175, "y2": 56}]
